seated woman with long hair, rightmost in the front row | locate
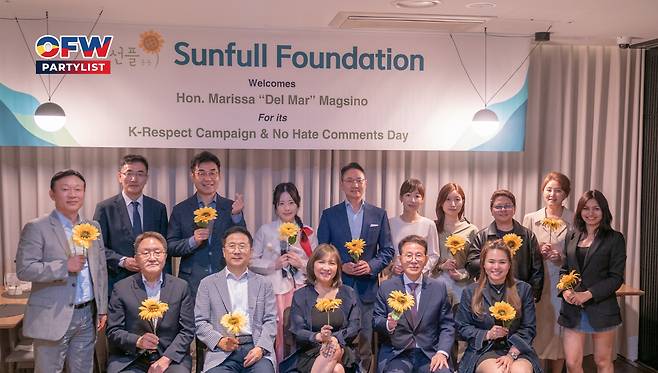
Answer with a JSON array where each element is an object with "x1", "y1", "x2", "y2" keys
[{"x1": 455, "y1": 239, "x2": 542, "y2": 373}]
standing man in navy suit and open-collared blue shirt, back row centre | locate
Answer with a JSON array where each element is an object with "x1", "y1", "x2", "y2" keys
[{"x1": 318, "y1": 162, "x2": 394, "y2": 372}]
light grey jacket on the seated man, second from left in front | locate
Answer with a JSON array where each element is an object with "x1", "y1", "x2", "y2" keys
[{"x1": 194, "y1": 269, "x2": 276, "y2": 372}]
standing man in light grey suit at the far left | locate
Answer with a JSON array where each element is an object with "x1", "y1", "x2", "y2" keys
[{"x1": 16, "y1": 170, "x2": 107, "y2": 373}]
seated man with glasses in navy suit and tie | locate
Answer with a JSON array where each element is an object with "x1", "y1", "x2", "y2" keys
[{"x1": 373, "y1": 235, "x2": 455, "y2": 373}]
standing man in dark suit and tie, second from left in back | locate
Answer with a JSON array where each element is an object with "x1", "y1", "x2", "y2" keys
[{"x1": 94, "y1": 154, "x2": 171, "y2": 294}]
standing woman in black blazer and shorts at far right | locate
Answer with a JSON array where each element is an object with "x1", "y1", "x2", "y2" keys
[{"x1": 558, "y1": 190, "x2": 626, "y2": 373}]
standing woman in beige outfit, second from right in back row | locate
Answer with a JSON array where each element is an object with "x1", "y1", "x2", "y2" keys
[{"x1": 523, "y1": 172, "x2": 573, "y2": 373}]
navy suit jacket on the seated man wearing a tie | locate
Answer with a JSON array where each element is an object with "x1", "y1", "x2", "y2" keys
[{"x1": 373, "y1": 275, "x2": 455, "y2": 373}]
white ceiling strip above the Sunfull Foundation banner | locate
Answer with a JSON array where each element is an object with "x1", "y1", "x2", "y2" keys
[{"x1": 0, "y1": 0, "x2": 658, "y2": 45}]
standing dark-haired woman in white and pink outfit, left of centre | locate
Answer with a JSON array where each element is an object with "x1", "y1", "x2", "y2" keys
[{"x1": 249, "y1": 183, "x2": 318, "y2": 361}]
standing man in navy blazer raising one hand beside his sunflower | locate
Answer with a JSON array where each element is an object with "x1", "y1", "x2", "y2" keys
[{"x1": 167, "y1": 151, "x2": 246, "y2": 296}]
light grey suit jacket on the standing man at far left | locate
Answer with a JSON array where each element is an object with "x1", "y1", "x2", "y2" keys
[{"x1": 16, "y1": 210, "x2": 107, "y2": 341}]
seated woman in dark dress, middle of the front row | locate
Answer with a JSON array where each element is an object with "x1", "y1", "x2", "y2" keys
[{"x1": 279, "y1": 244, "x2": 361, "y2": 373}]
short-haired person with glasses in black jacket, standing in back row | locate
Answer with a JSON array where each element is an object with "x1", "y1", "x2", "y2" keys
[{"x1": 466, "y1": 189, "x2": 544, "y2": 302}]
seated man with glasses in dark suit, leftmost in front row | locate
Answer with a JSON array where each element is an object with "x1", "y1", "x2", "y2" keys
[{"x1": 107, "y1": 232, "x2": 194, "y2": 373}]
